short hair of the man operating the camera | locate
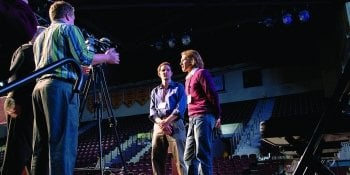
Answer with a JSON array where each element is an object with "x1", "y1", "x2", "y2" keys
[{"x1": 49, "y1": 1, "x2": 74, "y2": 21}]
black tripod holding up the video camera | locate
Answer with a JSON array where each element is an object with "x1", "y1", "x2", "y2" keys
[{"x1": 79, "y1": 64, "x2": 126, "y2": 175}]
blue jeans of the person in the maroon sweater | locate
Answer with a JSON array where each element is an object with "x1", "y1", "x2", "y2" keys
[{"x1": 184, "y1": 114, "x2": 215, "y2": 175}]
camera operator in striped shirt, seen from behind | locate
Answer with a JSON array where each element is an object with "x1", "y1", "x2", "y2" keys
[{"x1": 31, "y1": 1, "x2": 120, "y2": 175}]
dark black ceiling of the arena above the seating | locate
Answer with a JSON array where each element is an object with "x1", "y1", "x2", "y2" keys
[{"x1": 32, "y1": 0, "x2": 337, "y2": 85}]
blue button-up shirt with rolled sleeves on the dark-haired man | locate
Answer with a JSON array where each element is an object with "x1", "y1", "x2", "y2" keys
[{"x1": 149, "y1": 81, "x2": 187, "y2": 122}]
